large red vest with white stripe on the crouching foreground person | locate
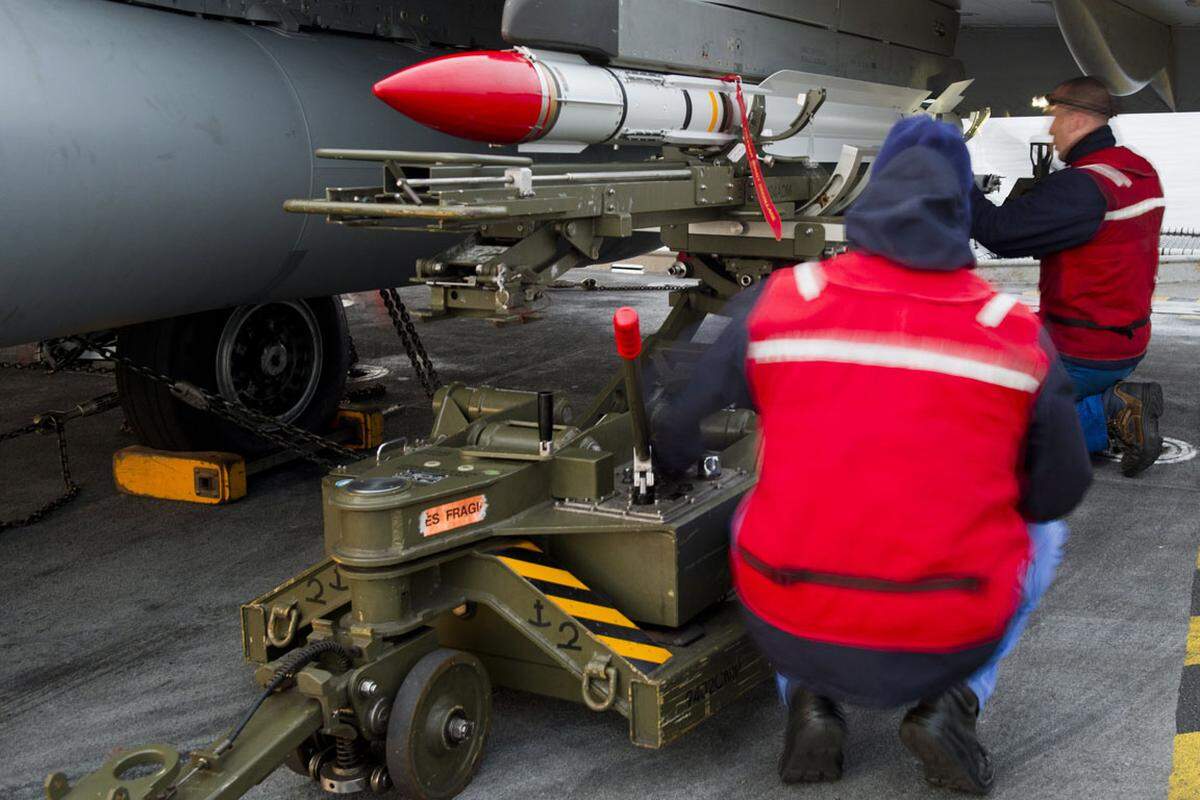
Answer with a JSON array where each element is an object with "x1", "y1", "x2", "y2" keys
[{"x1": 732, "y1": 253, "x2": 1049, "y2": 652}]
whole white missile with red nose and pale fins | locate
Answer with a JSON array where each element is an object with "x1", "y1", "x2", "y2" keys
[{"x1": 374, "y1": 48, "x2": 929, "y2": 162}]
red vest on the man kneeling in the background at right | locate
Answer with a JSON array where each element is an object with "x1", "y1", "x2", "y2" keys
[{"x1": 1040, "y1": 148, "x2": 1165, "y2": 361}]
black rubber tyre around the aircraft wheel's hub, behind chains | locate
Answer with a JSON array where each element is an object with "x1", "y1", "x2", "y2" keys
[{"x1": 116, "y1": 295, "x2": 350, "y2": 456}]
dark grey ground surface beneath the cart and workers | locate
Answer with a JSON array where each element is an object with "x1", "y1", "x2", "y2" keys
[{"x1": 0, "y1": 273, "x2": 1200, "y2": 800}]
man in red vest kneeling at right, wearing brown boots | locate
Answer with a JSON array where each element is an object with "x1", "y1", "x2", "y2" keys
[{"x1": 971, "y1": 78, "x2": 1164, "y2": 476}]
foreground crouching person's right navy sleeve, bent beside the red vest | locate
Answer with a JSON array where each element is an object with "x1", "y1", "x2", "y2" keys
[{"x1": 1020, "y1": 331, "x2": 1092, "y2": 522}]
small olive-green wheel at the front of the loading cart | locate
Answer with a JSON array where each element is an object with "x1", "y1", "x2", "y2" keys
[{"x1": 385, "y1": 649, "x2": 492, "y2": 800}]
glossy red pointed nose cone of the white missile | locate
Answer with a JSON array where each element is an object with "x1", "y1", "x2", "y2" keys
[{"x1": 374, "y1": 50, "x2": 545, "y2": 144}]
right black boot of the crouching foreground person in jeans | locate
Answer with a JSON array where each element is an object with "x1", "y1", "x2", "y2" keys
[{"x1": 900, "y1": 685, "x2": 992, "y2": 794}]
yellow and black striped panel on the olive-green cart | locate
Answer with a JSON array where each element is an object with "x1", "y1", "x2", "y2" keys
[{"x1": 493, "y1": 542, "x2": 672, "y2": 675}]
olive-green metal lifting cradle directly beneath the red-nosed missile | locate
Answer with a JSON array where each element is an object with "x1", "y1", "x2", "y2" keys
[{"x1": 283, "y1": 146, "x2": 844, "y2": 323}]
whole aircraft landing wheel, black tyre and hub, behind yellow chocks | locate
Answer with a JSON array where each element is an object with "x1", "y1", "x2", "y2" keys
[{"x1": 116, "y1": 296, "x2": 350, "y2": 455}]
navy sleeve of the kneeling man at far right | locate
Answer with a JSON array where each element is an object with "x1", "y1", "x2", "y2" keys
[{"x1": 971, "y1": 169, "x2": 1108, "y2": 258}]
